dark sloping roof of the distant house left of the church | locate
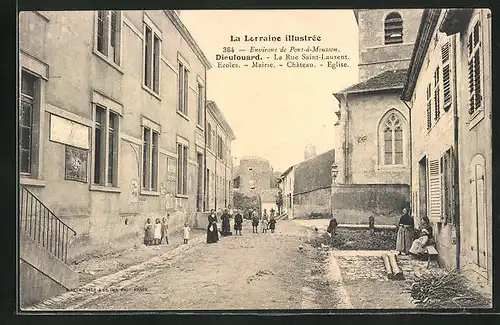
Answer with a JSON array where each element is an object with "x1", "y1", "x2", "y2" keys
[{"x1": 294, "y1": 149, "x2": 335, "y2": 194}]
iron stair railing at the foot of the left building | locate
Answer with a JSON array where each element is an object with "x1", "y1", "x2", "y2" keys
[{"x1": 19, "y1": 186, "x2": 76, "y2": 263}]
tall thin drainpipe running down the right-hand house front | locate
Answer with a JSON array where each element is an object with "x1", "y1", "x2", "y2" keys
[{"x1": 451, "y1": 35, "x2": 460, "y2": 272}]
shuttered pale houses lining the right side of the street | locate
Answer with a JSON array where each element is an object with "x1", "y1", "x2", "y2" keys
[{"x1": 402, "y1": 9, "x2": 493, "y2": 294}]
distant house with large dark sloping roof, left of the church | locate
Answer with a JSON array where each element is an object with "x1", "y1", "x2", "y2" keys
[{"x1": 280, "y1": 149, "x2": 335, "y2": 218}]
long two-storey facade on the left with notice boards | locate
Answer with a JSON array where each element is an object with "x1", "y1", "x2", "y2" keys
[{"x1": 19, "y1": 10, "x2": 219, "y2": 258}]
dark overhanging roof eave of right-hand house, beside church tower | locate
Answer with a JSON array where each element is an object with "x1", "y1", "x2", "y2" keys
[{"x1": 401, "y1": 9, "x2": 441, "y2": 101}]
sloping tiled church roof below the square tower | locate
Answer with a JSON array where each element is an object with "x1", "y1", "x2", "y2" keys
[{"x1": 336, "y1": 69, "x2": 408, "y2": 94}]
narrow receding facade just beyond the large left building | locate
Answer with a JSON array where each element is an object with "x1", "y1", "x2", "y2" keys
[{"x1": 205, "y1": 100, "x2": 235, "y2": 211}]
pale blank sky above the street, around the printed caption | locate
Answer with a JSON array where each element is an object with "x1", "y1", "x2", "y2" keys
[{"x1": 180, "y1": 10, "x2": 358, "y2": 172}]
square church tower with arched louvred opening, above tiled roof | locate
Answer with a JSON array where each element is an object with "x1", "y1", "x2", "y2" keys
[{"x1": 354, "y1": 9, "x2": 423, "y2": 82}]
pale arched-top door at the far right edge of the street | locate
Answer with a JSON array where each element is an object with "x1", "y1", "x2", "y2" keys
[{"x1": 470, "y1": 155, "x2": 488, "y2": 269}]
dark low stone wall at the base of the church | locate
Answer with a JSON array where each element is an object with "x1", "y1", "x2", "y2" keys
[{"x1": 331, "y1": 184, "x2": 410, "y2": 225}]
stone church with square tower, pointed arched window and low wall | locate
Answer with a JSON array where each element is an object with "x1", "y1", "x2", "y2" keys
[{"x1": 332, "y1": 9, "x2": 422, "y2": 224}]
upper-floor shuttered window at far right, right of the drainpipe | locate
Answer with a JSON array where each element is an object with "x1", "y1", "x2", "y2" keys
[{"x1": 467, "y1": 21, "x2": 482, "y2": 115}]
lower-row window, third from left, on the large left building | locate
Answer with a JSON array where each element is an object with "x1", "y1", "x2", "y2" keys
[{"x1": 142, "y1": 127, "x2": 160, "y2": 191}]
